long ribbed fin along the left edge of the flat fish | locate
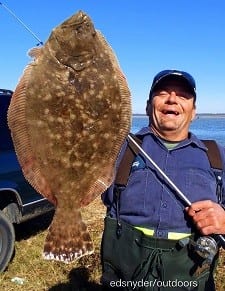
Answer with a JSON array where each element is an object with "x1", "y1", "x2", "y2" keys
[{"x1": 7, "y1": 65, "x2": 57, "y2": 205}]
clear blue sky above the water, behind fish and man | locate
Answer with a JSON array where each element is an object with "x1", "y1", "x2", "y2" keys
[{"x1": 0, "y1": 0, "x2": 225, "y2": 113}]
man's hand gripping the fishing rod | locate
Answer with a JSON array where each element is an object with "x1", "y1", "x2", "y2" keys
[{"x1": 186, "y1": 200, "x2": 225, "y2": 235}]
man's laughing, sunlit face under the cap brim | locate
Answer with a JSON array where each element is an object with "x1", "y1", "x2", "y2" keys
[{"x1": 147, "y1": 79, "x2": 195, "y2": 141}]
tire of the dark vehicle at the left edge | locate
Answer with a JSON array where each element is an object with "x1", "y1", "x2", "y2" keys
[{"x1": 0, "y1": 211, "x2": 15, "y2": 272}]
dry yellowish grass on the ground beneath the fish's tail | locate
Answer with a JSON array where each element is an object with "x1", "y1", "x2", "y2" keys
[{"x1": 0, "y1": 199, "x2": 225, "y2": 291}]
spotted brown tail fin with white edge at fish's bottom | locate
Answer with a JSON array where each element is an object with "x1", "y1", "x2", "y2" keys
[{"x1": 43, "y1": 207, "x2": 94, "y2": 263}]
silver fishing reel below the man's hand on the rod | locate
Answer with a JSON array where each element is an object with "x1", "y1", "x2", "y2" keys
[{"x1": 180, "y1": 236, "x2": 218, "y2": 264}]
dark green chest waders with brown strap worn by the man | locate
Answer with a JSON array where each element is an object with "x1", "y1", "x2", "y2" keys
[{"x1": 102, "y1": 135, "x2": 222, "y2": 291}]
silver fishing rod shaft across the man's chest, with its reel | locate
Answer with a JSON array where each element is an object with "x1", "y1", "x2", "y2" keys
[{"x1": 128, "y1": 134, "x2": 225, "y2": 262}]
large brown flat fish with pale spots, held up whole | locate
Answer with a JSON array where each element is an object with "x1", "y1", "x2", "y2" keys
[{"x1": 8, "y1": 11, "x2": 131, "y2": 262}]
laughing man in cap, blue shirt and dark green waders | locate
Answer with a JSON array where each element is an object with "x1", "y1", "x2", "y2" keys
[{"x1": 102, "y1": 70, "x2": 225, "y2": 291}]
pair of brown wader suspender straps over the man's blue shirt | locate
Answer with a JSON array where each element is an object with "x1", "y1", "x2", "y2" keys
[{"x1": 115, "y1": 133, "x2": 223, "y2": 235}]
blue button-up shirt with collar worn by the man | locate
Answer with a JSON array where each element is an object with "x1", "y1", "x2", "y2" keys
[{"x1": 102, "y1": 127, "x2": 225, "y2": 237}]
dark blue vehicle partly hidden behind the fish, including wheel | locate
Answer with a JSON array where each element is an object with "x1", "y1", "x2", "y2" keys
[{"x1": 0, "y1": 89, "x2": 54, "y2": 272}]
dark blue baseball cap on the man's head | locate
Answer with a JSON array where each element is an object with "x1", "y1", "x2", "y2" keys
[{"x1": 149, "y1": 70, "x2": 196, "y2": 100}]
